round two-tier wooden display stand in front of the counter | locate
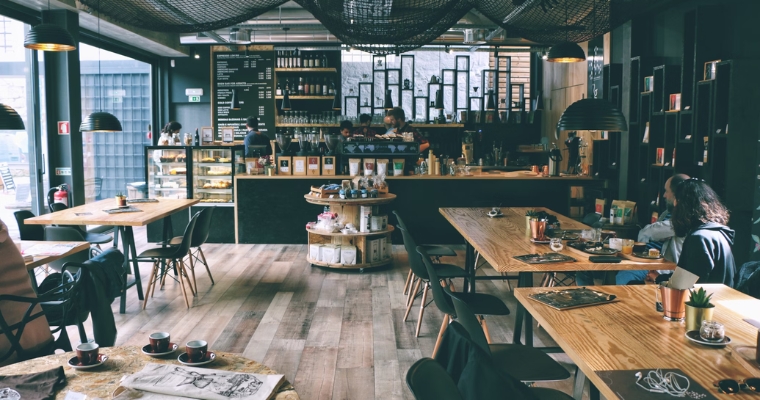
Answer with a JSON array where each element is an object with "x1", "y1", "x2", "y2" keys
[{"x1": 303, "y1": 193, "x2": 396, "y2": 271}]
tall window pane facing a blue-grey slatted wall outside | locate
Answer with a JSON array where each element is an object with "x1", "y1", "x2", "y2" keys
[{"x1": 79, "y1": 43, "x2": 151, "y2": 203}]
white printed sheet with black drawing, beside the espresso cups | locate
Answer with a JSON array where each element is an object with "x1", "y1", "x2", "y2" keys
[{"x1": 121, "y1": 363, "x2": 285, "y2": 400}]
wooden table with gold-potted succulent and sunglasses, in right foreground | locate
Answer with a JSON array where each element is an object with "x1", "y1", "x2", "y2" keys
[{"x1": 515, "y1": 284, "x2": 760, "y2": 399}]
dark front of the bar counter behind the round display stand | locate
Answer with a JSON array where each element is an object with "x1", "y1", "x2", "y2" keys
[{"x1": 235, "y1": 171, "x2": 606, "y2": 244}]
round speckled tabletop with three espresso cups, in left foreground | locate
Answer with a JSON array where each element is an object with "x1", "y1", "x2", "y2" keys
[{"x1": 0, "y1": 346, "x2": 299, "y2": 400}]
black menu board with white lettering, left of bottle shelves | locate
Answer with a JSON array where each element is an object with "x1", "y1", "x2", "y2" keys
[{"x1": 211, "y1": 50, "x2": 275, "y2": 141}]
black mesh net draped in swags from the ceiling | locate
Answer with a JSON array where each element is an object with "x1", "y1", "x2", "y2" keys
[{"x1": 79, "y1": 0, "x2": 662, "y2": 54}]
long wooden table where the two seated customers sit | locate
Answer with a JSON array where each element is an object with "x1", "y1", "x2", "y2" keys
[{"x1": 439, "y1": 207, "x2": 676, "y2": 346}]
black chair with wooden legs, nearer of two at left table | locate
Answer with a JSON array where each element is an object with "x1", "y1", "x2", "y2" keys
[{"x1": 135, "y1": 213, "x2": 200, "y2": 310}]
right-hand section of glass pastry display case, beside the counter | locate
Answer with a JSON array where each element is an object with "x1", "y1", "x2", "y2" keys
[{"x1": 192, "y1": 146, "x2": 245, "y2": 206}]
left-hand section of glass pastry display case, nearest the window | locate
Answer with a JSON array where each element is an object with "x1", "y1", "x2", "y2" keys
[{"x1": 145, "y1": 146, "x2": 190, "y2": 199}]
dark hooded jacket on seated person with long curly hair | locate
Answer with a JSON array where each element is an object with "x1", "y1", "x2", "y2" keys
[{"x1": 678, "y1": 222, "x2": 736, "y2": 287}]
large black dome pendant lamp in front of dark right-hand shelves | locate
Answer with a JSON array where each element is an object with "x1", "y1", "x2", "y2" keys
[{"x1": 557, "y1": 99, "x2": 628, "y2": 132}]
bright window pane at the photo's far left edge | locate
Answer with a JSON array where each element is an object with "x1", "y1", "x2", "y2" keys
[{"x1": 0, "y1": 16, "x2": 44, "y2": 237}]
